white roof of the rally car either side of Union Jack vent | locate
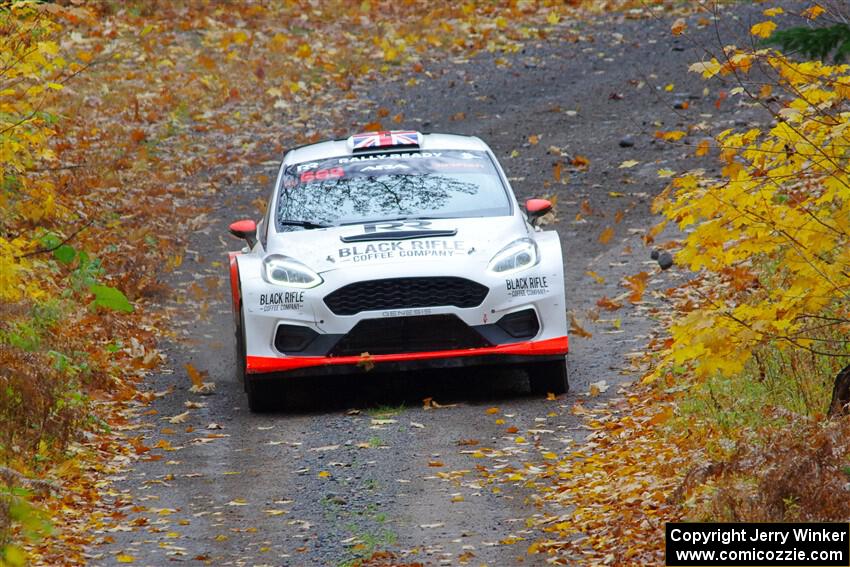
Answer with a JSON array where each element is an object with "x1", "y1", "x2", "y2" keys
[{"x1": 283, "y1": 133, "x2": 489, "y2": 165}]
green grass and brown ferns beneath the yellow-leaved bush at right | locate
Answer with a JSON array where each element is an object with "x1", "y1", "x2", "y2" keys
[{"x1": 670, "y1": 333, "x2": 850, "y2": 522}]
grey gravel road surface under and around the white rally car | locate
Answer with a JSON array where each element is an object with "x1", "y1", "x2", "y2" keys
[{"x1": 92, "y1": 5, "x2": 772, "y2": 565}]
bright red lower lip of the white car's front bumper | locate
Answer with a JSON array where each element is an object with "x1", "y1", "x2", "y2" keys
[{"x1": 246, "y1": 336, "x2": 569, "y2": 376}]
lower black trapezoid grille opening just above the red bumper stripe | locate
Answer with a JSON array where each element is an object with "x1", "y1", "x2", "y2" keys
[{"x1": 330, "y1": 315, "x2": 490, "y2": 356}]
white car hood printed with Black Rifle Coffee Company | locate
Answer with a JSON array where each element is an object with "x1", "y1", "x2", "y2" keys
[{"x1": 267, "y1": 216, "x2": 528, "y2": 273}]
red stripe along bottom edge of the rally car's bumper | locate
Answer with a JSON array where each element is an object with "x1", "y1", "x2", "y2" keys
[{"x1": 246, "y1": 337, "x2": 570, "y2": 374}]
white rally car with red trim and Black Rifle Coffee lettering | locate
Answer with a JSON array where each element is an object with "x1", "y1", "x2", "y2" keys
[{"x1": 230, "y1": 131, "x2": 568, "y2": 411}]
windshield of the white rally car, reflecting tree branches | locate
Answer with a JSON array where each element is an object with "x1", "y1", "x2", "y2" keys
[{"x1": 275, "y1": 150, "x2": 511, "y2": 232}]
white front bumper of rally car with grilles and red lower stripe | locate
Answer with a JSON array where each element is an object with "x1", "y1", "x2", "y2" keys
[{"x1": 234, "y1": 233, "x2": 568, "y2": 375}]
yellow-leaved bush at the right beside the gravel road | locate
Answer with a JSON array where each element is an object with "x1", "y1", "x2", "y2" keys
[{"x1": 656, "y1": 47, "x2": 850, "y2": 376}]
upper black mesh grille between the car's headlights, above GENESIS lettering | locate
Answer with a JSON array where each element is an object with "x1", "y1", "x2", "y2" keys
[{"x1": 325, "y1": 277, "x2": 489, "y2": 315}]
